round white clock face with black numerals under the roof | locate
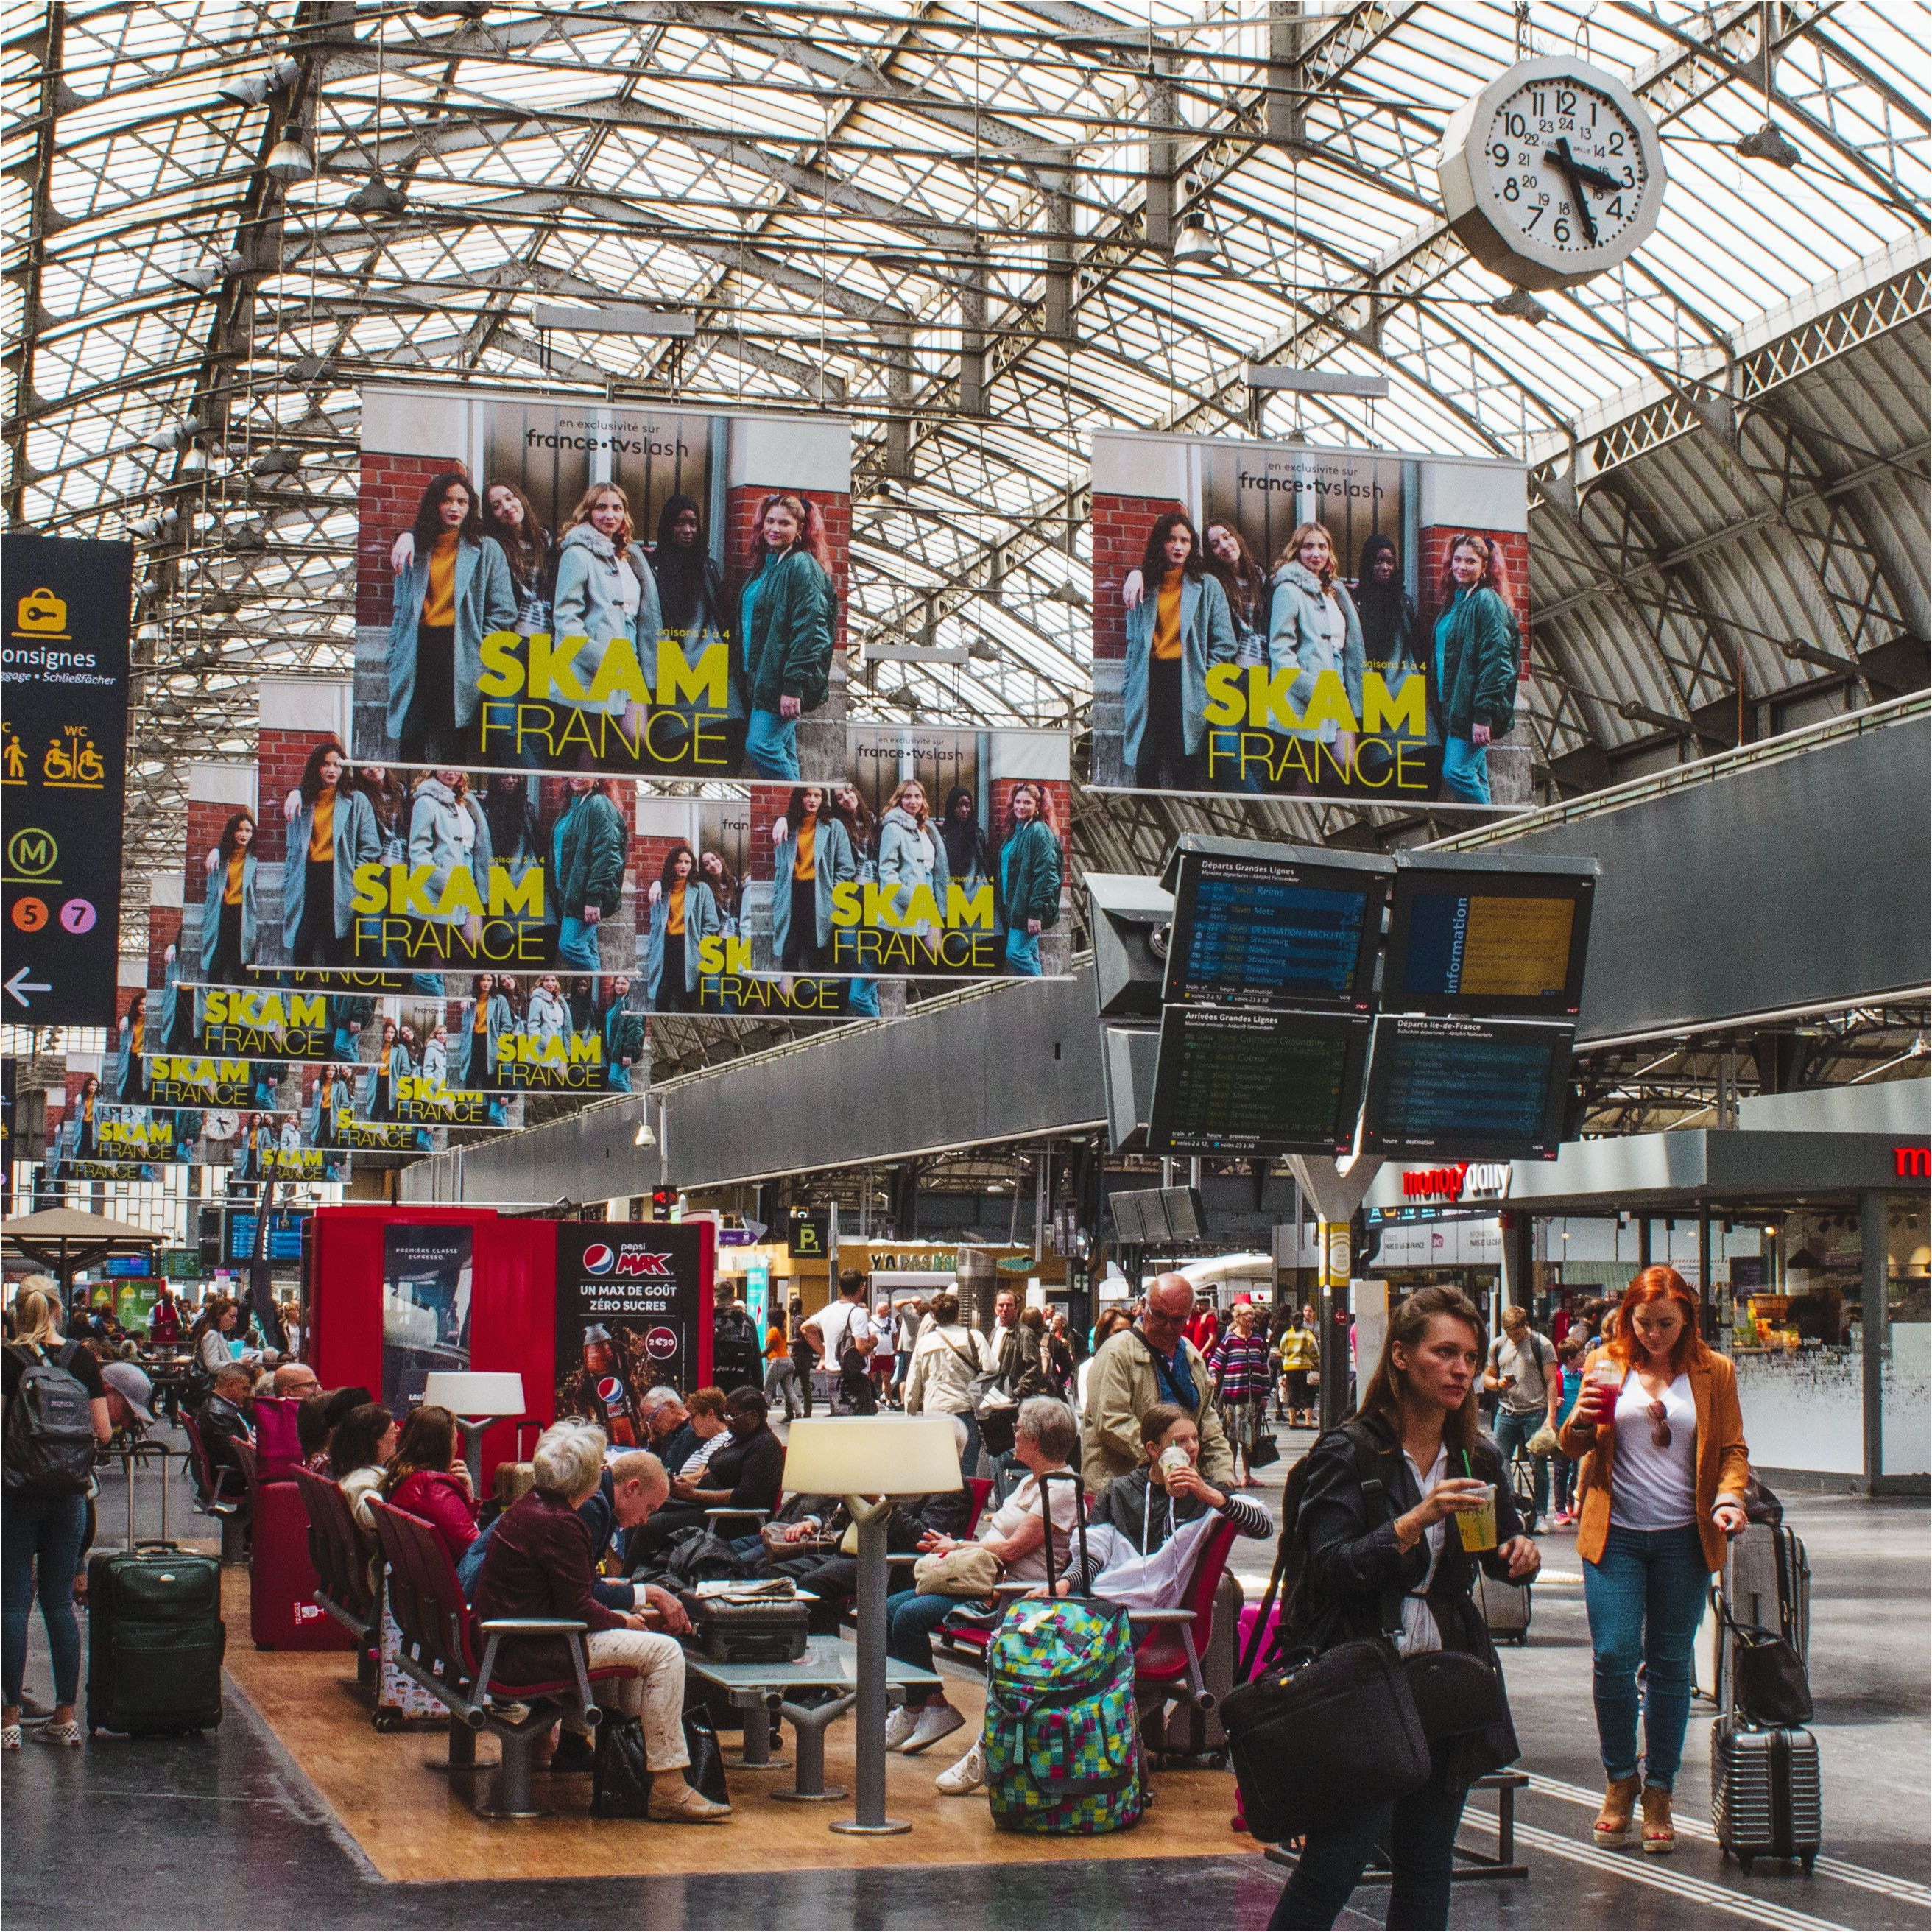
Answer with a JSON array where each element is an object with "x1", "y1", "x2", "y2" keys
[{"x1": 1482, "y1": 75, "x2": 1650, "y2": 261}]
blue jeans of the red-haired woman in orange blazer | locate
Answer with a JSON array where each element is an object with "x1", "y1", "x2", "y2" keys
[{"x1": 1582, "y1": 1523, "x2": 1710, "y2": 1791}]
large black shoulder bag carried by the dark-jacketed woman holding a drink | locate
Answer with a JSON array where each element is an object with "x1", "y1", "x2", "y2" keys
[{"x1": 1221, "y1": 1637, "x2": 1430, "y2": 1843}]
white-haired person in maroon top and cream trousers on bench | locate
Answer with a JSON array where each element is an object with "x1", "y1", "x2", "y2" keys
[{"x1": 473, "y1": 1422, "x2": 730, "y2": 1824}]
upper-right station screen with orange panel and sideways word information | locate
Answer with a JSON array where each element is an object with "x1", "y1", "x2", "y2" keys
[{"x1": 1381, "y1": 861, "x2": 1596, "y2": 1018}]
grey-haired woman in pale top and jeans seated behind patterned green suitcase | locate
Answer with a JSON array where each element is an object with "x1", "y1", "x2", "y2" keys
[{"x1": 885, "y1": 1395, "x2": 1080, "y2": 1756}]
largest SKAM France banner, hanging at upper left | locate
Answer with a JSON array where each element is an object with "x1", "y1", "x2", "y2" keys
[{"x1": 352, "y1": 388, "x2": 852, "y2": 778}]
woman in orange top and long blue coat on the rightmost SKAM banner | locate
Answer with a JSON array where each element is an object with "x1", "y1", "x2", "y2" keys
[{"x1": 1121, "y1": 510, "x2": 1235, "y2": 792}]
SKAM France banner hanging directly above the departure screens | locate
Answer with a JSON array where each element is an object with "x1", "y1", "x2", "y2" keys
[{"x1": 1093, "y1": 431, "x2": 1530, "y2": 809}]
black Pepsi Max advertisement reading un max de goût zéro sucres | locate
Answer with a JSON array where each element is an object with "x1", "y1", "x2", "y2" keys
[{"x1": 557, "y1": 1221, "x2": 717, "y2": 1449}]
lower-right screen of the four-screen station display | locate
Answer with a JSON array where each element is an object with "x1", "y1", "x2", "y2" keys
[{"x1": 1362, "y1": 1015, "x2": 1576, "y2": 1161}]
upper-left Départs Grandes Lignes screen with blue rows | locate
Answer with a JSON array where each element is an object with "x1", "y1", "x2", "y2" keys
[{"x1": 1163, "y1": 848, "x2": 1389, "y2": 1012}]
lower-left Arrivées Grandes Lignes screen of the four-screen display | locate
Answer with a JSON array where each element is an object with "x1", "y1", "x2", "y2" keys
[{"x1": 1148, "y1": 1006, "x2": 1369, "y2": 1155}]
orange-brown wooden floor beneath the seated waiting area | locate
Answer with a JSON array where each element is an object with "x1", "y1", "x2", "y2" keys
[{"x1": 224, "y1": 1569, "x2": 1260, "y2": 1882}]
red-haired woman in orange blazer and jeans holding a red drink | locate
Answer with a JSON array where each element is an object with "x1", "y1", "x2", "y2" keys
[{"x1": 1559, "y1": 1267, "x2": 1750, "y2": 1852}]
